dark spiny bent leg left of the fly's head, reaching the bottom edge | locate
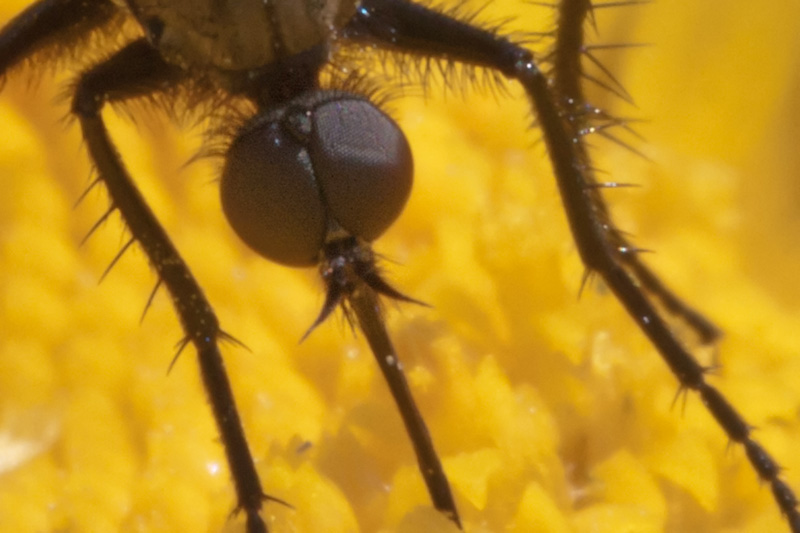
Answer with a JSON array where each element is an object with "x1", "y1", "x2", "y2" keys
[{"x1": 72, "y1": 39, "x2": 274, "y2": 533}]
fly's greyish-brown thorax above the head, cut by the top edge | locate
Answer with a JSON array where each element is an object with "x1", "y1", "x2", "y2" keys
[{"x1": 124, "y1": 0, "x2": 357, "y2": 71}]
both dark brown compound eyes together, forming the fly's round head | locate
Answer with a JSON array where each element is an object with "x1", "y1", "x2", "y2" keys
[{"x1": 220, "y1": 91, "x2": 413, "y2": 266}]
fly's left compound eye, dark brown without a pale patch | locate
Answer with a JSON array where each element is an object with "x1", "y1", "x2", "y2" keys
[{"x1": 220, "y1": 117, "x2": 327, "y2": 266}]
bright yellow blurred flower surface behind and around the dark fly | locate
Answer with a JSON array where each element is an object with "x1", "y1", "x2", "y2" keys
[{"x1": 0, "y1": 0, "x2": 800, "y2": 533}]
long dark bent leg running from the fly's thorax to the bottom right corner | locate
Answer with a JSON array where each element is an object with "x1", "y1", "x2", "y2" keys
[{"x1": 344, "y1": 0, "x2": 800, "y2": 533}]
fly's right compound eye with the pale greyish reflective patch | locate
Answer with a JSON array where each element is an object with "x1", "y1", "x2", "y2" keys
[{"x1": 308, "y1": 95, "x2": 414, "y2": 241}]
